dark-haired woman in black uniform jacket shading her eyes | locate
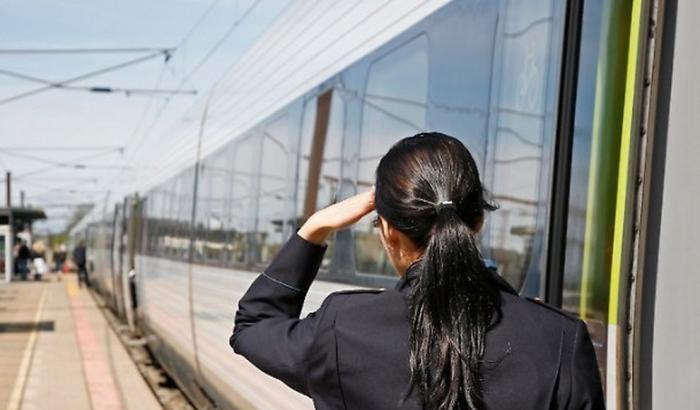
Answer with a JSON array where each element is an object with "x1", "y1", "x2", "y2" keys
[{"x1": 230, "y1": 133, "x2": 604, "y2": 410}]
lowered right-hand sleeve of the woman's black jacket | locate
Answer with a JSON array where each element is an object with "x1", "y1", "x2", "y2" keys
[{"x1": 568, "y1": 321, "x2": 605, "y2": 410}]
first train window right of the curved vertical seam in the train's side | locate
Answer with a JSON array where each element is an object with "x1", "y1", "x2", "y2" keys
[{"x1": 194, "y1": 146, "x2": 232, "y2": 265}]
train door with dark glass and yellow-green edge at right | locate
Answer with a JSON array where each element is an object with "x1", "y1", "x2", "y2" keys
[{"x1": 544, "y1": 1, "x2": 640, "y2": 408}]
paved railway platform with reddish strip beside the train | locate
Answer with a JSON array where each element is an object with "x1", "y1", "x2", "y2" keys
[{"x1": 0, "y1": 275, "x2": 161, "y2": 410}]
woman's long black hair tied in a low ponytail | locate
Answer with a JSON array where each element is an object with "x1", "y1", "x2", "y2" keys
[{"x1": 375, "y1": 132, "x2": 500, "y2": 410}]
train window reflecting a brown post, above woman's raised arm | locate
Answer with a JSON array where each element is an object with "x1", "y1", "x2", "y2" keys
[{"x1": 297, "y1": 90, "x2": 345, "y2": 268}]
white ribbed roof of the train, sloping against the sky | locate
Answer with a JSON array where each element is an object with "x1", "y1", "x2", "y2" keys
[{"x1": 137, "y1": 0, "x2": 449, "y2": 192}]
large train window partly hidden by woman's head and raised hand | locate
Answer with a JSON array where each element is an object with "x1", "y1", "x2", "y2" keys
[{"x1": 353, "y1": 36, "x2": 428, "y2": 276}]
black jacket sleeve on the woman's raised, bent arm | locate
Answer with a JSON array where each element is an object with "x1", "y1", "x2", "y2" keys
[{"x1": 229, "y1": 234, "x2": 329, "y2": 395}]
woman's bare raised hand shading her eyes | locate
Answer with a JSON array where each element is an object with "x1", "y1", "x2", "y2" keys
[{"x1": 297, "y1": 188, "x2": 374, "y2": 245}]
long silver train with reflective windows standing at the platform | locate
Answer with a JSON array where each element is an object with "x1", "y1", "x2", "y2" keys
[{"x1": 71, "y1": 0, "x2": 700, "y2": 409}]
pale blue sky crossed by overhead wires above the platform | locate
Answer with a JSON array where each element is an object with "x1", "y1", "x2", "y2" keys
[{"x1": 0, "y1": 0, "x2": 293, "y2": 231}]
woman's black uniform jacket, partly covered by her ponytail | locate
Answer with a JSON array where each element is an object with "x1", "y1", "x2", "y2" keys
[{"x1": 230, "y1": 235, "x2": 604, "y2": 410}]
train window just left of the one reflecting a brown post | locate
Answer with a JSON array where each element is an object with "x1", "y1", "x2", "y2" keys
[{"x1": 255, "y1": 114, "x2": 291, "y2": 264}]
